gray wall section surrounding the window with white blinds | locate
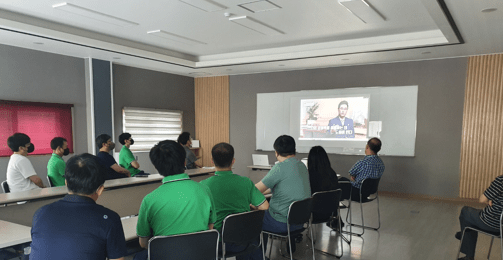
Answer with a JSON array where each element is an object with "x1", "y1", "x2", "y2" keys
[{"x1": 113, "y1": 65, "x2": 197, "y2": 173}]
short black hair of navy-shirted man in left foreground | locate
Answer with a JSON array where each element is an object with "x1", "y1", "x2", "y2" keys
[{"x1": 65, "y1": 153, "x2": 106, "y2": 195}]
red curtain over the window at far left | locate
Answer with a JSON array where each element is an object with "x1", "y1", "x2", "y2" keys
[{"x1": 0, "y1": 100, "x2": 73, "y2": 157}]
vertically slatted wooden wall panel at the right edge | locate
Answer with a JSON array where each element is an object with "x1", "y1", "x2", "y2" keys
[{"x1": 459, "y1": 54, "x2": 503, "y2": 198}]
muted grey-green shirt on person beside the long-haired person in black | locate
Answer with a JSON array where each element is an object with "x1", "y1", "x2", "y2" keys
[{"x1": 262, "y1": 157, "x2": 311, "y2": 223}]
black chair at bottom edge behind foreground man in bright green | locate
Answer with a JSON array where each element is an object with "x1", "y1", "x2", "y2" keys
[{"x1": 148, "y1": 229, "x2": 220, "y2": 260}]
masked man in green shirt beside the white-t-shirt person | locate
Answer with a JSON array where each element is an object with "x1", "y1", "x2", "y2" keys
[{"x1": 47, "y1": 137, "x2": 70, "y2": 187}]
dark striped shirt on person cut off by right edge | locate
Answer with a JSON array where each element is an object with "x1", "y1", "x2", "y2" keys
[{"x1": 480, "y1": 175, "x2": 503, "y2": 229}]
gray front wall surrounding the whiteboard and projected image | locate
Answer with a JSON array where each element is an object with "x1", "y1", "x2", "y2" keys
[{"x1": 230, "y1": 58, "x2": 467, "y2": 197}]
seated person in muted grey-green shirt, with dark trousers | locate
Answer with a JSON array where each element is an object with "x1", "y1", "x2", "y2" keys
[{"x1": 253, "y1": 135, "x2": 311, "y2": 260}]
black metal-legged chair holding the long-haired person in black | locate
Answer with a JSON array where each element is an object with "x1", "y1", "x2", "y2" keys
[{"x1": 310, "y1": 189, "x2": 349, "y2": 258}]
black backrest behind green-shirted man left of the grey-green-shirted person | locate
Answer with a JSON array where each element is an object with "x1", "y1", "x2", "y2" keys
[{"x1": 222, "y1": 210, "x2": 265, "y2": 245}]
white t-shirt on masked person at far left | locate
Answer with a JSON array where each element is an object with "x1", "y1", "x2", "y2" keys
[{"x1": 7, "y1": 154, "x2": 39, "y2": 192}]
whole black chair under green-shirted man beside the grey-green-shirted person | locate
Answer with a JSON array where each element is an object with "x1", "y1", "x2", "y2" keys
[{"x1": 218, "y1": 210, "x2": 265, "y2": 259}]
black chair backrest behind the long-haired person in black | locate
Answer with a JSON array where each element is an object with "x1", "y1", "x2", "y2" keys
[{"x1": 311, "y1": 189, "x2": 342, "y2": 223}]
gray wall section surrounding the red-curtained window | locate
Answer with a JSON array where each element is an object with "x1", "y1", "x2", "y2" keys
[{"x1": 0, "y1": 45, "x2": 87, "y2": 185}]
